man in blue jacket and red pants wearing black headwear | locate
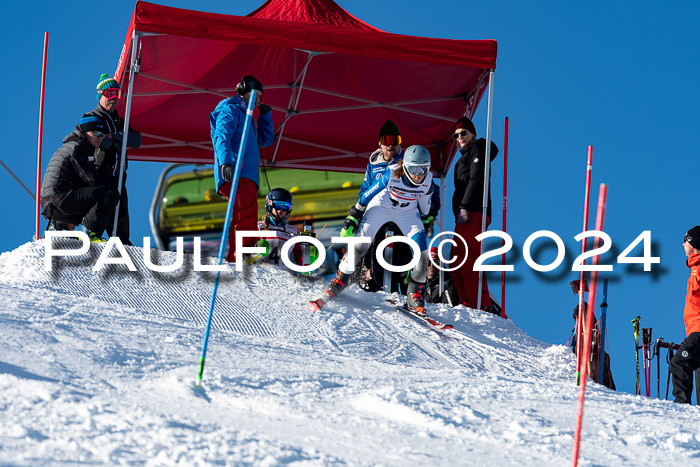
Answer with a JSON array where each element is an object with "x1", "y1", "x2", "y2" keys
[{"x1": 209, "y1": 75, "x2": 274, "y2": 262}]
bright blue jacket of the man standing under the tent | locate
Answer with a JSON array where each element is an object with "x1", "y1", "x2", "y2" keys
[{"x1": 209, "y1": 96, "x2": 275, "y2": 192}]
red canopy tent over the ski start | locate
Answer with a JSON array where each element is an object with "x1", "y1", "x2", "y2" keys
[{"x1": 115, "y1": 0, "x2": 496, "y2": 176}]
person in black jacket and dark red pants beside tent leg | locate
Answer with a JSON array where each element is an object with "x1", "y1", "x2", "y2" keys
[{"x1": 450, "y1": 117, "x2": 498, "y2": 314}]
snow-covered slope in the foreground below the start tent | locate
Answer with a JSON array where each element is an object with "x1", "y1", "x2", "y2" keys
[{"x1": 0, "y1": 240, "x2": 700, "y2": 465}]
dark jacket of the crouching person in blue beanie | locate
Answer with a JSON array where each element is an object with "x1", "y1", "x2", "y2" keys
[{"x1": 41, "y1": 129, "x2": 103, "y2": 209}]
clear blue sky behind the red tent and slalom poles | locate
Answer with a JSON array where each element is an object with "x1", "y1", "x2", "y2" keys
[{"x1": 0, "y1": 0, "x2": 700, "y2": 396}]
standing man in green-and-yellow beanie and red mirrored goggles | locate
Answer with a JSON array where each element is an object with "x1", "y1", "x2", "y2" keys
[{"x1": 84, "y1": 73, "x2": 141, "y2": 245}]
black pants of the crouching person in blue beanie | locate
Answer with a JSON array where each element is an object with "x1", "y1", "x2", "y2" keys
[{"x1": 51, "y1": 186, "x2": 119, "y2": 236}]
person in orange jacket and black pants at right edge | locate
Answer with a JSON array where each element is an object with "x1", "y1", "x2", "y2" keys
[{"x1": 670, "y1": 225, "x2": 700, "y2": 405}]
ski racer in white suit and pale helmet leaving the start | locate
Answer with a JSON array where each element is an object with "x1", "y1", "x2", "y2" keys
[{"x1": 315, "y1": 146, "x2": 434, "y2": 314}]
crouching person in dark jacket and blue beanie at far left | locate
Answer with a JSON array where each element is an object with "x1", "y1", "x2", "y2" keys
[{"x1": 41, "y1": 116, "x2": 119, "y2": 241}]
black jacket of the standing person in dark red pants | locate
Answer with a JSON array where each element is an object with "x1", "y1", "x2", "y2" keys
[{"x1": 452, "y1": 138, "x2": 498, "y2": 220}]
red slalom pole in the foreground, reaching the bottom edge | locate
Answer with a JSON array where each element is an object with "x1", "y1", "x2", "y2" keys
[{"x1": 571, "y1": 183, "x2": 608, "y2": 467}]
